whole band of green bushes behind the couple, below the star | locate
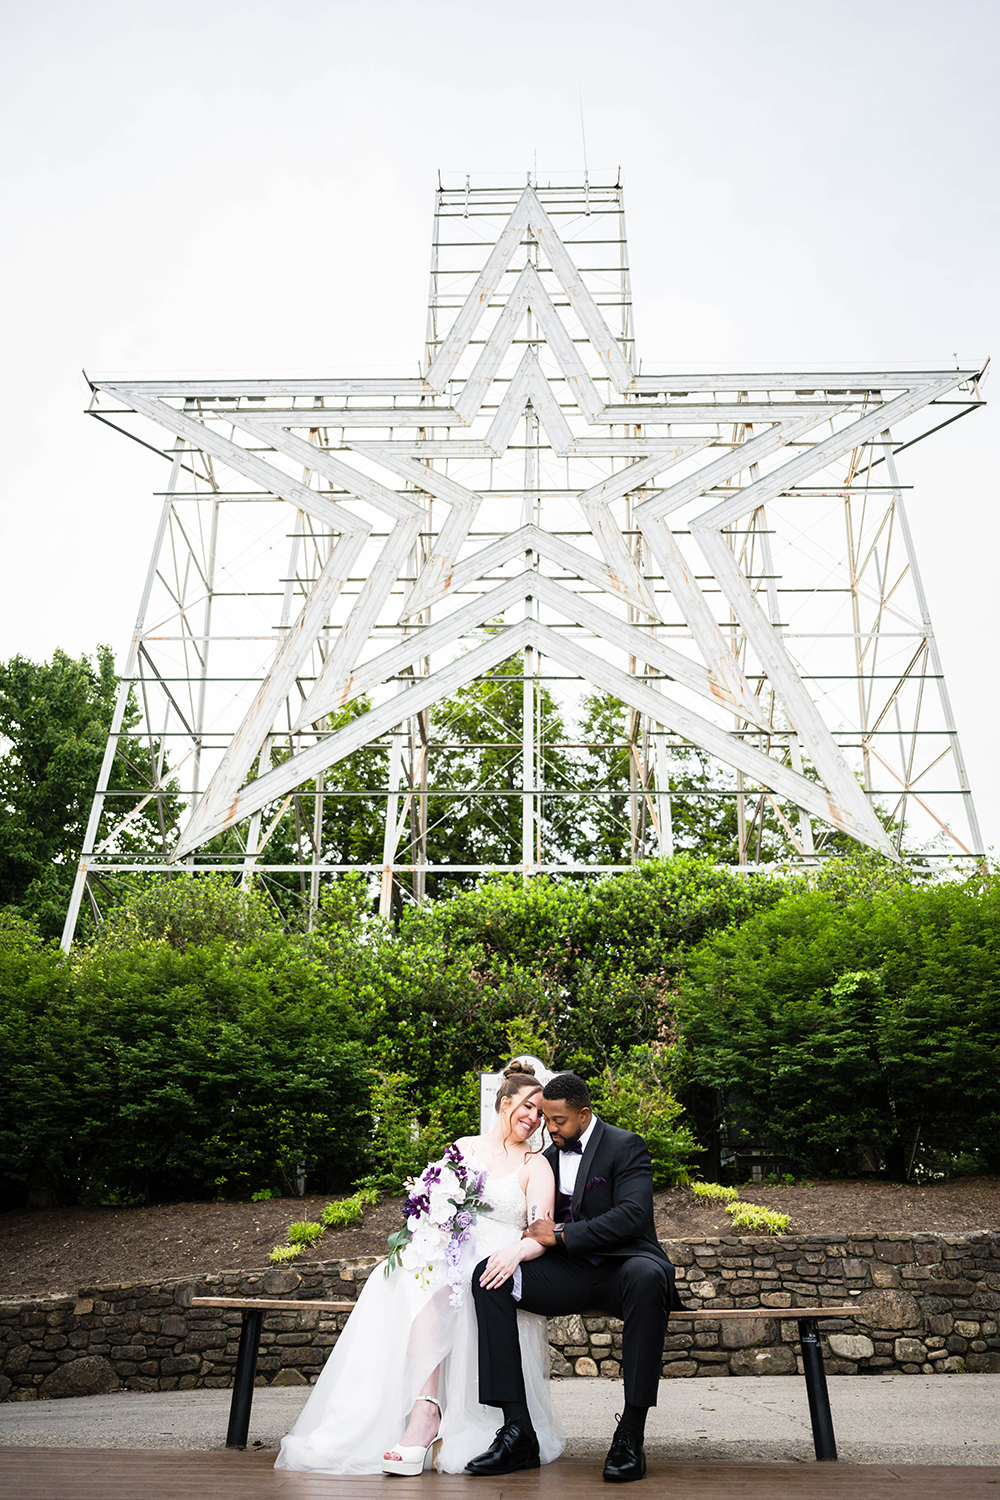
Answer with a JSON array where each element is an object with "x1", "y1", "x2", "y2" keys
[{"x1": 0, "y1": 857, "x2": 1000, "y2": 1205}]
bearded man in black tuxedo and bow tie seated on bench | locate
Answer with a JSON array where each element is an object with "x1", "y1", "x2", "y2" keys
[{"x1": 466, "y1": 1073, "x2": 682, "y2": 1484}]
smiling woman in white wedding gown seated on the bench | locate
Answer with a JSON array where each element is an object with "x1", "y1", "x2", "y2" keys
[{"x1": 274, "y1": 1062, "x2": 564, "y2": 1475}]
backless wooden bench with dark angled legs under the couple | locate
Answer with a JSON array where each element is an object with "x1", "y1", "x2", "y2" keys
[{"x1": 190, "y1": 1298, "x2": 858, "y2": 1463}]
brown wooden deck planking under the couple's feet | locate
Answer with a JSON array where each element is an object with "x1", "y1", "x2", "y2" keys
[{"x1": 0, "y1": 1448, "x2": 1000, "y2": 1500}]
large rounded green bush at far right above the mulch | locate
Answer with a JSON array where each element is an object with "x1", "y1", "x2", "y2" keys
[{"x1": 679, "y1": 872, "x2": 1000, "y2": 1178}]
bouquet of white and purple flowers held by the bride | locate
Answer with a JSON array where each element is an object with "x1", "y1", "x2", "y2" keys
[{"x1": 385, "y1": 1146, "x2": 490, "y2": 1308}]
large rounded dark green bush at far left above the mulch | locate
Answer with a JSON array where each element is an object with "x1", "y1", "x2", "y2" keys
[{"x1": 0, "y1": 894, "x2": 367, "y2": 1203}]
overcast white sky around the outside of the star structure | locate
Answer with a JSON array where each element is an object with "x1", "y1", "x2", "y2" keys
[{"x1": 0, "y1": 0, "x2": 1000, "y2": 849}]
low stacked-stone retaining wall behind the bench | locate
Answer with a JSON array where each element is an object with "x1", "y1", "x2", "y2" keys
[{"x1": 0, "y1": 1233, "x2": 1000, "y2": 1401}]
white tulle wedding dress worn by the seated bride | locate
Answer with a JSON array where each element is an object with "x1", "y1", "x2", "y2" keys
[{"x1": 274, "y1": 1157, "x2": 565, "y2": 1475}]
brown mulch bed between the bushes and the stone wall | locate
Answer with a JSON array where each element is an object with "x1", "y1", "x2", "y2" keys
[{"x1": 0, "y1": 1178, "x2": 1000, "y2": 1299}]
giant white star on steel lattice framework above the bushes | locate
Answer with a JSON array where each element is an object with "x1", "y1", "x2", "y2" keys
[{"x1": 66, "y1": 179, "x2": 982, "y2": 942}]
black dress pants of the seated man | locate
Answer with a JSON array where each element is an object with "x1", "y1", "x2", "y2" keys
[{"x1": 472, "y1": 1254, "x2": 679, "y2": 1407}]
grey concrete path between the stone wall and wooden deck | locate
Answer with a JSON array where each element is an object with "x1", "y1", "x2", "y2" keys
[{"x1": 0, "y1": 1376, "x2": 1000, "y2": 1466}]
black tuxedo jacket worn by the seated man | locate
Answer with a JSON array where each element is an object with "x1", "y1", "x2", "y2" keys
[{"x1": 543, "y1": 1116, "x2": 669, "y2": 1265}]
